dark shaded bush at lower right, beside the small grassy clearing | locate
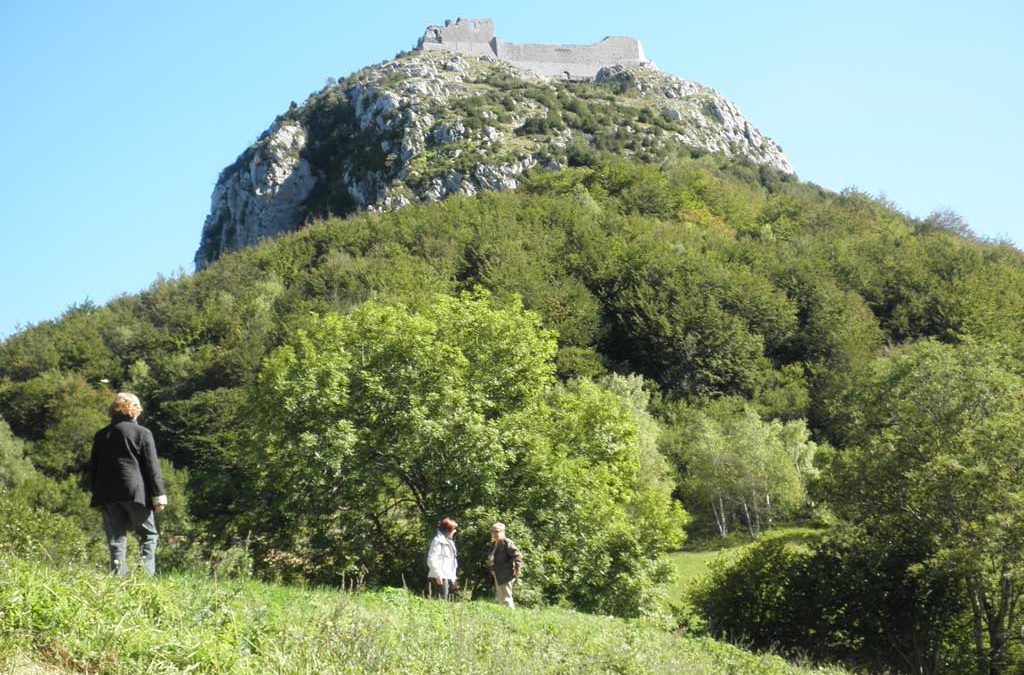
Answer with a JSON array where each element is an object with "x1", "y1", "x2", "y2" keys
[{"x1": 688, "y1": 530, "x2": 974, "y2": 672}]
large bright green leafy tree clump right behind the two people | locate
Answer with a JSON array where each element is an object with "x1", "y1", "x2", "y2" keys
[{"x1": 231, "y1": 293, "x2": 685, "y2": 615}]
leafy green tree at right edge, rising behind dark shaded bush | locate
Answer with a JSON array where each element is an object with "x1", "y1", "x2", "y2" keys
[{"x1": 833, "y1": 342, "x2": 1024, "y2": 672}]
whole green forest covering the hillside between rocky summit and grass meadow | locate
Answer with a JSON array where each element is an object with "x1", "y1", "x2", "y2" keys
[{"x1": 0, "y1": 156, "x2": 1024, "y2": 673}]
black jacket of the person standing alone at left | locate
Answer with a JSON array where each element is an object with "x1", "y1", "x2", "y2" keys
[{"x1": 89, "y1": 417, "x2": 165, "y2": 507}]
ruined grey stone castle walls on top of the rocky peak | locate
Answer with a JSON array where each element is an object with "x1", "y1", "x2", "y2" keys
[{"x1": 416, "y1": 18, "x2": 654, "y2": 80}]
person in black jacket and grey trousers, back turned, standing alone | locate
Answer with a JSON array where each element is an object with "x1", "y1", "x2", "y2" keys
[{"x1": 89, "y1": 392, "x2": 167, "y2": 577}]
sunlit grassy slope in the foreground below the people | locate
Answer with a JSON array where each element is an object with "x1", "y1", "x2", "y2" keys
[{"x1": 0, "y1": 558, "x2": 840, "y2": 675}]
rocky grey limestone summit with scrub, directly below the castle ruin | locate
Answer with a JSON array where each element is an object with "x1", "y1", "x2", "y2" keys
[{"x1": 196, "y1": 51, "x2": 793, "y2": 268}]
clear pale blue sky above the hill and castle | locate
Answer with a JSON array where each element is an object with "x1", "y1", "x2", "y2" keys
[{"x1": 0, "y1": 0, "x2": 1024, "y2": 338}]
